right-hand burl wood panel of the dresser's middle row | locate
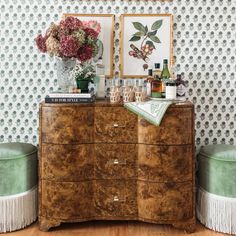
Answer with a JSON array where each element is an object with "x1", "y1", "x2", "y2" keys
[{"x1": 138, "y1": 144, "x2": 193, "y2": 182}]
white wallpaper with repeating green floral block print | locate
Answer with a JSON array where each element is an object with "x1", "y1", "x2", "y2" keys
[{"x1": 0, "y1": 0, "x2": 236, "y2": 147}]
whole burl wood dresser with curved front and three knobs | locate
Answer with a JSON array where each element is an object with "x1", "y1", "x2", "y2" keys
[{"x1": 39, "y1": 101, "x2": 195, "y2": 232}]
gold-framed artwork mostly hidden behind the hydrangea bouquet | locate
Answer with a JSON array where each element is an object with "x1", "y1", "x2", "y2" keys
[{"x1": 63, "y1": 14, "x2": 115, "y2": 78}]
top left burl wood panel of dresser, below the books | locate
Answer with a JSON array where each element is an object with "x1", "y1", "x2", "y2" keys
[{"x1": 41, "y1": 106, "x2": 94, "y2": 144}]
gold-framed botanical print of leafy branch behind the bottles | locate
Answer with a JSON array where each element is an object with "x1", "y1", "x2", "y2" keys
[{"x1": 120, "y1": 14, "x2": 173, "y2": 78}]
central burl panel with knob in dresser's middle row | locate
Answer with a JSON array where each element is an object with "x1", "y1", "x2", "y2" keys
[{"x1": 94, "y1": 144, "x2": 138, "y2": 179}]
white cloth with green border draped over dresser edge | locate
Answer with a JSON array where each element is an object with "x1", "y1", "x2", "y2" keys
[{"x1": 124, "y1": 100, "x2": 172, "y2": 126}]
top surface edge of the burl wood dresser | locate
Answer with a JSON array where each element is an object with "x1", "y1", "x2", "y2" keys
[{"x1": 40, "y1": 99, "x2": 193, "y2": 108}]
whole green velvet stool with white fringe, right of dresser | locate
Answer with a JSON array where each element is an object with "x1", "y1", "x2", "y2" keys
[{"x1": 197, "y1": 144, "x2": 236, "y2": 234}]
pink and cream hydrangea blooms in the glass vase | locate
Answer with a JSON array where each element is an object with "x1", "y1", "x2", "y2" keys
[{"x1": 35, "y1": 16, "x2": 101, "y2": 63}]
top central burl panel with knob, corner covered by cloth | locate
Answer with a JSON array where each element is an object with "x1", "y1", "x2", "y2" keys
[{"x1": 95, "y1": 107, "x2": 137, "y2": 143}]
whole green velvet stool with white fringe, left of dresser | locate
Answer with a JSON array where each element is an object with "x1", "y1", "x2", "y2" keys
[{"x1": 0, "y1": 143, "x2": 38, "y2": 233}]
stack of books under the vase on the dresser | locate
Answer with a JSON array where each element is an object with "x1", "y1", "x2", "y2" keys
[{"x1": 45, "y1": 91, "x2": 95, "y2": 103}]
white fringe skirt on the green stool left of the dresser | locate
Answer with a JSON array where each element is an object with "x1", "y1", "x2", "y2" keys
[{"x1": 0, "y1": 186, "x2": 37, "y2": 233}]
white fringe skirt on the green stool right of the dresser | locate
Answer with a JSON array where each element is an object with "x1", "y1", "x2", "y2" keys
[{"x1": 197, "y1": 187, "x2": 236, "y2": 235}]
